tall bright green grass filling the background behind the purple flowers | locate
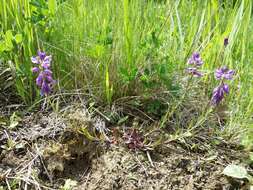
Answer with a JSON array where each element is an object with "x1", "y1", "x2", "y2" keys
[{"x1": 0, "y1": 0, "x2": 253, "y2": 148}]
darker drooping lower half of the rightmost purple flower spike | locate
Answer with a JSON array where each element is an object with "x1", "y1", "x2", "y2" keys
[{"x1": 211, "y1": 83, "x2": 229, "y2": 105}]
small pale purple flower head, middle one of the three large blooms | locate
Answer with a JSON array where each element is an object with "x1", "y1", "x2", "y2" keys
[{"x1": 187, "y1": 52, "x2": 203, "y2": 77}]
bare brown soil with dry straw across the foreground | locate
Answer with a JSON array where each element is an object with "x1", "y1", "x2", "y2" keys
[{"x1": 0, "y1": 108, "x2": 250, "y2": 190}]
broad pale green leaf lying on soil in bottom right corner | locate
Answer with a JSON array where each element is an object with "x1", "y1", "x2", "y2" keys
[{"x1": 223, "y1": 164, "x2": 251, "y2": 180}]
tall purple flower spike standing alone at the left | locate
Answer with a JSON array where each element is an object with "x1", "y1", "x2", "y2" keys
[{"x1": 31, "y1": 51, "x2": 55, "y2": 96}]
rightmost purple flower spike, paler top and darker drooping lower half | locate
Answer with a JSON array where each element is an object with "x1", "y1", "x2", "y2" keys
[{"x1": 211, "y1": 66, "x2": 235, "y2": 105}]
